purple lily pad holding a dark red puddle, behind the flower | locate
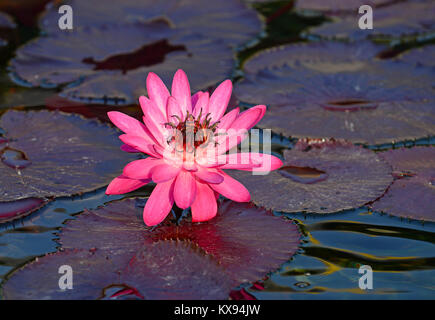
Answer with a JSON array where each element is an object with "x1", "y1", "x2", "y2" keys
[{"x1": 11, "y1": 20, "x2": 233, "y2": 104}]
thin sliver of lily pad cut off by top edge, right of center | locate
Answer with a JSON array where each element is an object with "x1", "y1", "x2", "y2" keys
[{"x1": 296, "y1": 0, "x2": 397, "y2": 14}]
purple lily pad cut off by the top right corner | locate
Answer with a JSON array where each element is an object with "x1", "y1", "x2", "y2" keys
[{"x1": 309, "y1": 1, "x2": 435, "y2": 40}]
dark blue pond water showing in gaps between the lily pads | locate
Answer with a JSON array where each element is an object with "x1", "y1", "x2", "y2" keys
[{"x1": 0, "y1": 0, "x2": 435, "y2": 300}]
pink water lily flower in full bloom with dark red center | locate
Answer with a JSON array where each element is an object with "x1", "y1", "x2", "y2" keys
[{"x1": 106, "y1": 70, "x2": 282, "y2": 226}]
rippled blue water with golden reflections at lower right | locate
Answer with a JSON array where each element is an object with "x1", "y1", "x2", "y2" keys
[{"x1": 247, "y1": 208, "x2": 435, "y2": 299}]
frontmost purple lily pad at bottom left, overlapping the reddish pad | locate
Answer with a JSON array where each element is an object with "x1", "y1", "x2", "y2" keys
[{"x1": 3, "y1": 241, "x2": 231, "y2": 300}]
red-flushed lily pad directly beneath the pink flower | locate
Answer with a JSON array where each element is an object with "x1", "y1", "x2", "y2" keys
[{"x1": 59, "y1": 200, "x2": 299, "y2": 286}]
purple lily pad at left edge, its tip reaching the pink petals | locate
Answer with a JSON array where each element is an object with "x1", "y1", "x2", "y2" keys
[{"x1": 0, "y1": 111, "x2": 135, "y2": 220}]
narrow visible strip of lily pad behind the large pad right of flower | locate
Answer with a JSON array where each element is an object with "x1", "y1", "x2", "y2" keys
[{"x1": 243, "y1": 41, "x2": 385, "y2": 73}]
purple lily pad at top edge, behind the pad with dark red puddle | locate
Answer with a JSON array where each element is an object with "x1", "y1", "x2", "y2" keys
[{"x1": 40, "y1": 0, "x2": 262, "y2": 47}]
